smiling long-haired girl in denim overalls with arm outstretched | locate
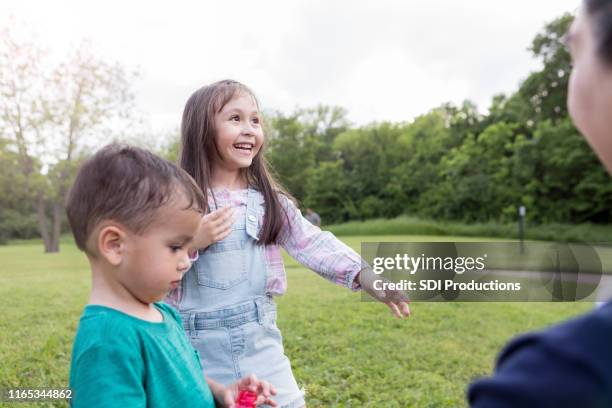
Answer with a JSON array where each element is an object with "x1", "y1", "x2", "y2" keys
[{"x1": 168, "y1": 80, "x2": 410, "y2": 407}]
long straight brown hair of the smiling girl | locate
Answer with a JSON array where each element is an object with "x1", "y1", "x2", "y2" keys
[{"x1": 179, "y1": 80, "x2": 294, "y2": 245}]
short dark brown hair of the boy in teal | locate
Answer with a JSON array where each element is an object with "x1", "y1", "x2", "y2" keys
[{"x1": 66, "y1": 143, "x2": 205, "y2": 253}]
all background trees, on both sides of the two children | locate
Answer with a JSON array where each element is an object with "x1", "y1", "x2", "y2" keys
[{"x1": 0, "y1": 14, "x2": 612, "y2": 252}]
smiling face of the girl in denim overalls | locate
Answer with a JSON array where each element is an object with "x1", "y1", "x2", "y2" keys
[{"x1": 214, "y1": 93, "x2": 264, "y2": 171}]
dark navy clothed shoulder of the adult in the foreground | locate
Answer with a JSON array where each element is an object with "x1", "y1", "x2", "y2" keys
[{"x1": 468, "y1": 304, "x2": 612, "y2": 407}]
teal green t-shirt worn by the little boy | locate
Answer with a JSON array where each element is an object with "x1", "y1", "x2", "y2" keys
[{"x1": 70, "y1": 303, "x2": 215, "y2": 408}]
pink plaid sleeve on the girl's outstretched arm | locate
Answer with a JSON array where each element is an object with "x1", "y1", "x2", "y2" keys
[{"x1": 280, "y1": 195, "x2": 366, "y2": 290}]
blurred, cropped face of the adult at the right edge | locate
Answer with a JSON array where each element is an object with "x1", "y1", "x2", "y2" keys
[{"x1": 567, "y1": 10, "x2": 612, "y2": 173}]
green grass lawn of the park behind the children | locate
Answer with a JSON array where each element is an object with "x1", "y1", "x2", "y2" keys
[{"x1": 0, "y1": 236, "x2": 592, "y2": 408}]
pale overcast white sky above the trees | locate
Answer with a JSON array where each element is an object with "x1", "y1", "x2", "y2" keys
[{"x1": 0, "y1": 0, "x2": 580, "y2": 137}]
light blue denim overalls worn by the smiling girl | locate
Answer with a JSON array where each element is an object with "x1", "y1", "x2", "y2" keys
[{"x1": 179, "y1": 188, "x2": 305, "y2": 408}]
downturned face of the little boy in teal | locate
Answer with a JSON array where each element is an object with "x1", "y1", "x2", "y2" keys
[{"x1": 117, "y1": 200, "x2": 201, "y2": 303}]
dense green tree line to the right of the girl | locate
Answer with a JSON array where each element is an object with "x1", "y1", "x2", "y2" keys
[{"x1": 268, "y1": 14, "x2": 612, "y2": 223}]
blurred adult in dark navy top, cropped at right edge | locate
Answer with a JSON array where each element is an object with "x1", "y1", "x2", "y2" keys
[{"x1": 468, "y1": 0, "x2": 612, "y2": 408}]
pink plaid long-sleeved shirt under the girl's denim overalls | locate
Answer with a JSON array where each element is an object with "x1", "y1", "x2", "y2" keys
[{"x1": 166, "y1": 188, "x2": 362, "y2": 306}]
